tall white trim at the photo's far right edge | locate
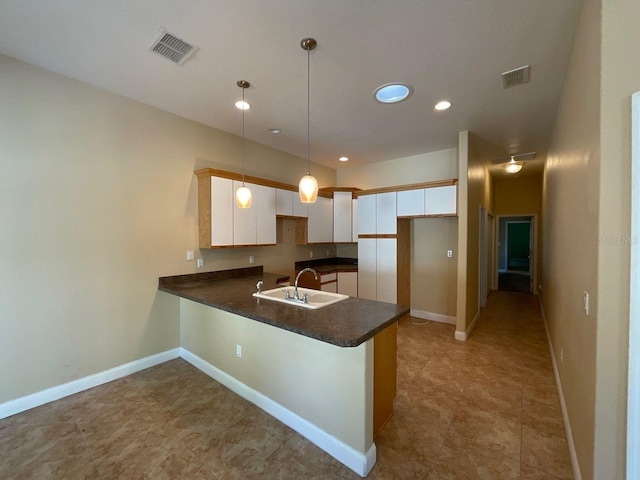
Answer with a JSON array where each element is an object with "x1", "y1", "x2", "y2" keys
[{"x1": 627, "y1": 92, "x2": 640, "y2": 478}]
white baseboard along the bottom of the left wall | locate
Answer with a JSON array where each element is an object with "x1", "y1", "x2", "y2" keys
[{"x1": 0, "y1": 348, "x2": 180, "y2": 419}]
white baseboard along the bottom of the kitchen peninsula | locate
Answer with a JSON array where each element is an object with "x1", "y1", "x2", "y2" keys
[{"x1": 180, "y1": 348, "x2": 376, "y2": 477}]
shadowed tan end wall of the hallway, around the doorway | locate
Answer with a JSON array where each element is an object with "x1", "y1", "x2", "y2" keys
[{"x1": 493, "y1": 175, "x2": 543, "y2": 293}]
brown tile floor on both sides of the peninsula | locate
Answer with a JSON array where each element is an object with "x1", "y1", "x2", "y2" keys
[{"x1": 0, "y1": 292, "x2": 573, "y2": 480}]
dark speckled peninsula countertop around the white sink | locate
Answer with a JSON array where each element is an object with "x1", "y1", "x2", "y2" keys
[{"x1": 158, "y1": 267, "x2": 409, "y2": 347}]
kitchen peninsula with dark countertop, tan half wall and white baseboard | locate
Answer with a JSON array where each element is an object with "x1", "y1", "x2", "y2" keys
[{"x1": 158, "y1": 267, "x2": 409, "y2": 476}]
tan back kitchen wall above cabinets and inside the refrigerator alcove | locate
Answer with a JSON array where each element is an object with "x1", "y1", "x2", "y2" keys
[{"x1": 337, "y1": 149, "x2": 458, "y2": 316}]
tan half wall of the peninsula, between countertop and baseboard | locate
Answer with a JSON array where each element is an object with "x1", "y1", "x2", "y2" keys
[{"x1": 181, "y1": 300, "x2": 373, "y2": 453}]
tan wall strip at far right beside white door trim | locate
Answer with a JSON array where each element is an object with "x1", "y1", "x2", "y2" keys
[{"x1": 594, "y1": 0, "x2": 640, "y2": 478}]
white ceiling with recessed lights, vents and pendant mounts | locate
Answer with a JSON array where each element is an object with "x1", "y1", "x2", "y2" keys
[{"x1": 0, "y1": 0, "x2": 581, "y2": 176}]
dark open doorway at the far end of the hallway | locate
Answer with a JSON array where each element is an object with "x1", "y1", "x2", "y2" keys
[{"x1": 498, "y1": 215, "x2": 535, "y2": 293}]
